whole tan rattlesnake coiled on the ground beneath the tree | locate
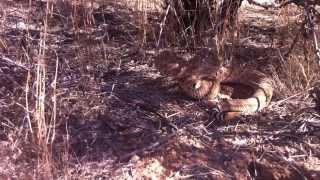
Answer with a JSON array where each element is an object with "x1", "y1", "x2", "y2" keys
[{"x1": 155, "y1": 51, "x2": 273, "y2": 120}]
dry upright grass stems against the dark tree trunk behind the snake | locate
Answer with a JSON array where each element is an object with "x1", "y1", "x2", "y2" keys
[{"x1": 157, "y1": 0, "x2": 242, "y2": 67}]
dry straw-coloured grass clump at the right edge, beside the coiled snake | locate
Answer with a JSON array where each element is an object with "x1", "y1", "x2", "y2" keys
[{"x1": 277, "y1": 6, "x2": 320, "y2": 92}]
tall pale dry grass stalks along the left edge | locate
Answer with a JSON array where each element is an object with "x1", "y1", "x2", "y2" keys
[{"x1": 0, "y1": 1, "x2": 105, "y2": 179}]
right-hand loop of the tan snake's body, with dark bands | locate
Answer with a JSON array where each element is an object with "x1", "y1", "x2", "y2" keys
[{"x1": 200, "y1": 70, "x2": 273, "y2": 120}]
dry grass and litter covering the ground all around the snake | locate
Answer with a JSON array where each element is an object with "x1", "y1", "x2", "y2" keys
[{"x1": 0, "y1": 0, "x2": 320, "y2": 179}]
